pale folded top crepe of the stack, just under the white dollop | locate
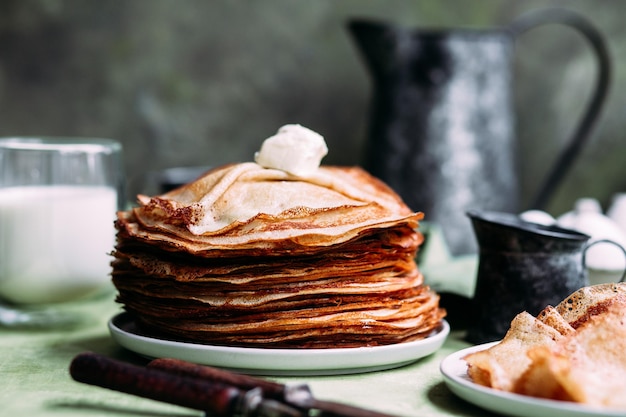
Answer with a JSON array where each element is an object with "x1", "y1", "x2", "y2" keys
[{"x1": 129, "y1": 162, "x2": 423, "y2": 253}]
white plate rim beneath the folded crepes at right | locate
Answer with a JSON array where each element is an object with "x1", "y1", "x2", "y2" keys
[{"x1": 440, "y1": 342, "x2": 626, "y2": 417}]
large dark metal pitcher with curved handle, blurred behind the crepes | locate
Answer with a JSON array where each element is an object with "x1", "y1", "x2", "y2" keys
[{"x1": 349, "y1": 9, "x2": 610, "y2": 255}]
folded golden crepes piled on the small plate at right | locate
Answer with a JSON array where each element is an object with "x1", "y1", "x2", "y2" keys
[{"x1": 463, "y1": 283, "x2": 626, "y2": 410}]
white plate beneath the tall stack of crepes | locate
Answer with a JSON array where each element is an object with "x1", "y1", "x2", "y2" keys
[{"x1": 109, "y1": 313, "x2": 450, "y2": 375}]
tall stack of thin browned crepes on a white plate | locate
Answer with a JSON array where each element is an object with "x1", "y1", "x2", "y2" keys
[{"x1": 112, "y1": 163, "x2": 445, "y2": 348}]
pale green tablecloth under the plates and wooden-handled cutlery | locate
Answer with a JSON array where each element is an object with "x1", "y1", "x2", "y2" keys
[{"x1": 0, "y1": 291, "x2": 489, "y2": 417}]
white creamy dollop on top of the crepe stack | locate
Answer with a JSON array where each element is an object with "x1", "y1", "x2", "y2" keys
[{"x1": 254, "y1": 124, "x2": 328, "y2": 177}]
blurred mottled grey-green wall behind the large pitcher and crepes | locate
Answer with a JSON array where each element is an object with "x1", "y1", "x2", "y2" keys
[{"x1": 0, "y1": 0, "x2": 626, "y2": 215}]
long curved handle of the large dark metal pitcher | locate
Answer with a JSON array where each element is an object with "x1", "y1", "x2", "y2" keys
[{"x1": 509, "y1": 9, "x2": 611, "y2": 210}]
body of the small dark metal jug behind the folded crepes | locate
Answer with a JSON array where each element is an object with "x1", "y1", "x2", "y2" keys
[{"x1": 467, "y1": 211, "x2": 590, "y2": 343}]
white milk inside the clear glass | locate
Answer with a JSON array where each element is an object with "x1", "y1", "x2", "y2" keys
[{"x1": 0, "y1": 185, "x2": 117, "y2": 304}]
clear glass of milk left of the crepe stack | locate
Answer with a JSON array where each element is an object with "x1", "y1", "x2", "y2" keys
[{"x1": 0, "y1": 137, "x2": 125, "y2": 306}]
